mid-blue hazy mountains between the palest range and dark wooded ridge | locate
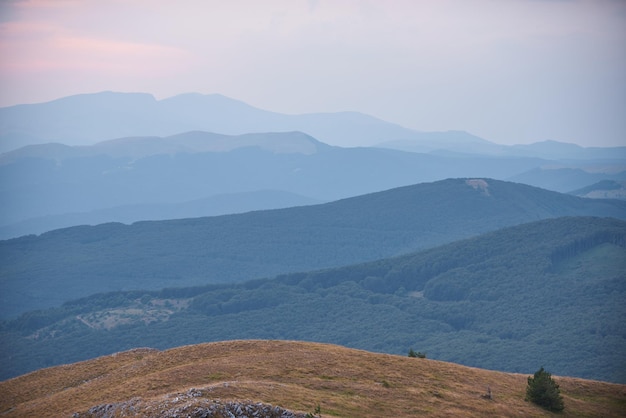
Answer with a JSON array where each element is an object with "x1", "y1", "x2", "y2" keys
[{"x1": 0, "y1": 127, "x2": 626, "y2": 239}]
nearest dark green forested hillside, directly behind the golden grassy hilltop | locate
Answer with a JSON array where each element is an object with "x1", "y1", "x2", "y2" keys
[{"x1": 0, "y1": 217, "x2": 626, "y2": 383}]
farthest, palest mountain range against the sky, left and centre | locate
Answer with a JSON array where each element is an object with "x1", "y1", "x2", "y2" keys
[{"x1": 0, "y1": 92, "x2": 422, "y2": 151}]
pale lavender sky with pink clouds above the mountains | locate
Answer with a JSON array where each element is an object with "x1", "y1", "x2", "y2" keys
[{"x1": 0, "y1": 0, "x2": 626, "y2": 146}]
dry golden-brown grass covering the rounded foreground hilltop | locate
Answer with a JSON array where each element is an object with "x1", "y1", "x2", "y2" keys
[{"x1": 0, "y1": 341, "x2": 626, "y2": 417}]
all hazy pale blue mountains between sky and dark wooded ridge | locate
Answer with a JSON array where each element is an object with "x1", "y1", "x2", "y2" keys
[{"x1": 0, "y1": 92, "x2": 626, "y2": 238}]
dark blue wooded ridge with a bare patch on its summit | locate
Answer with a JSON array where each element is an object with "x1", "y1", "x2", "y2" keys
[{"x1": 0, "y1": 179, "x2": 626, "y2": 318}]
